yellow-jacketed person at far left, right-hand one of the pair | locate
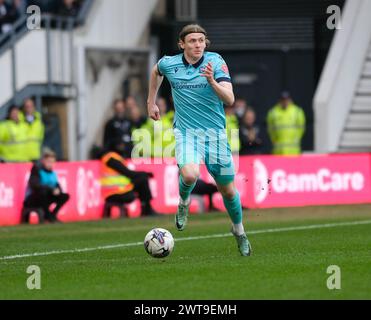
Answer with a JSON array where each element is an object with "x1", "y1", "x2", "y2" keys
[{"x1": 20, "y1": 99, "x2": 45, "y2": 161}]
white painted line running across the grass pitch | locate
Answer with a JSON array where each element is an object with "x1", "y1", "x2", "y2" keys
[{"x1": 0, "y1": 220, "x2": 371, "y2": 260}]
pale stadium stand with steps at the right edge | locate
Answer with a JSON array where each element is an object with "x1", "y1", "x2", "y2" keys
[{"x1": 314, "y1": 1, "x2": 371, "y2": 152}]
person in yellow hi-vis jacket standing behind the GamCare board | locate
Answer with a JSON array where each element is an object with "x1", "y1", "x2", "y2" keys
[{"x1": 267, "y1": 91, "x2": 305, "y2": 155}]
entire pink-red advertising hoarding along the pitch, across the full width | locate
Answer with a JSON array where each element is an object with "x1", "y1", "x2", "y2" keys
[{"x1": 0, "y1": 154, "x2": 371, "y2": 226}]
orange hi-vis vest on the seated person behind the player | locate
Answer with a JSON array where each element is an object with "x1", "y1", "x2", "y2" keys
[{"x1": 100, "y1": 152, "x2": 134, "y2": 199}]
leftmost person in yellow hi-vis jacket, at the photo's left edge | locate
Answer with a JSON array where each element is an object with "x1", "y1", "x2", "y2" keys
[{"x1": 0, "y1": 106, "x2": 29, "y2": 162}]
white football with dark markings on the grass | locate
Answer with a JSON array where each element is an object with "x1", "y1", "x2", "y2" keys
[{"x1": 144, "y1": 228, "x2": 174, "y2": 258}]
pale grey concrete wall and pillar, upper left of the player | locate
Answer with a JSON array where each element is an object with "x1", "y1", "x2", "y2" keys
[{"x1": 74, "y1": 0, "x2": 157, "y2": 160}]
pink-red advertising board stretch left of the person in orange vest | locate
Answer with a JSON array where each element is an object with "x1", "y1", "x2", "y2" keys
[{"x1": 0, "y1": 161, "x2": 103, "y2": 226}]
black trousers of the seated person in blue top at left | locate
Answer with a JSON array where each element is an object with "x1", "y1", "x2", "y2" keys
[{"x1": 23, "y1": 193, "x2": 70, "y2": 220}]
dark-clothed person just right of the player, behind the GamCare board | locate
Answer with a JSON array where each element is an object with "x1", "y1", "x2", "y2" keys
[{"x1": 240, "y1": 107, "x2": 263, "y2": 155}]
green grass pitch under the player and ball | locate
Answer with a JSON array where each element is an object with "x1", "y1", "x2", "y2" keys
[{"x1": 0, "y1": 205, "x2": 371, "y2": 299}]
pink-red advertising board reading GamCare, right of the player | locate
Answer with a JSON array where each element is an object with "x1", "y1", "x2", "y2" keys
[{"x1": 242, "y1": 154, "x2": 371, "y2": 208}]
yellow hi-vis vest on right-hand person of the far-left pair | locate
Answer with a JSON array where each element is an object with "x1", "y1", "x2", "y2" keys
[{"x1": 19, "y1": 112, "x2": 45, "y2": 161}]
